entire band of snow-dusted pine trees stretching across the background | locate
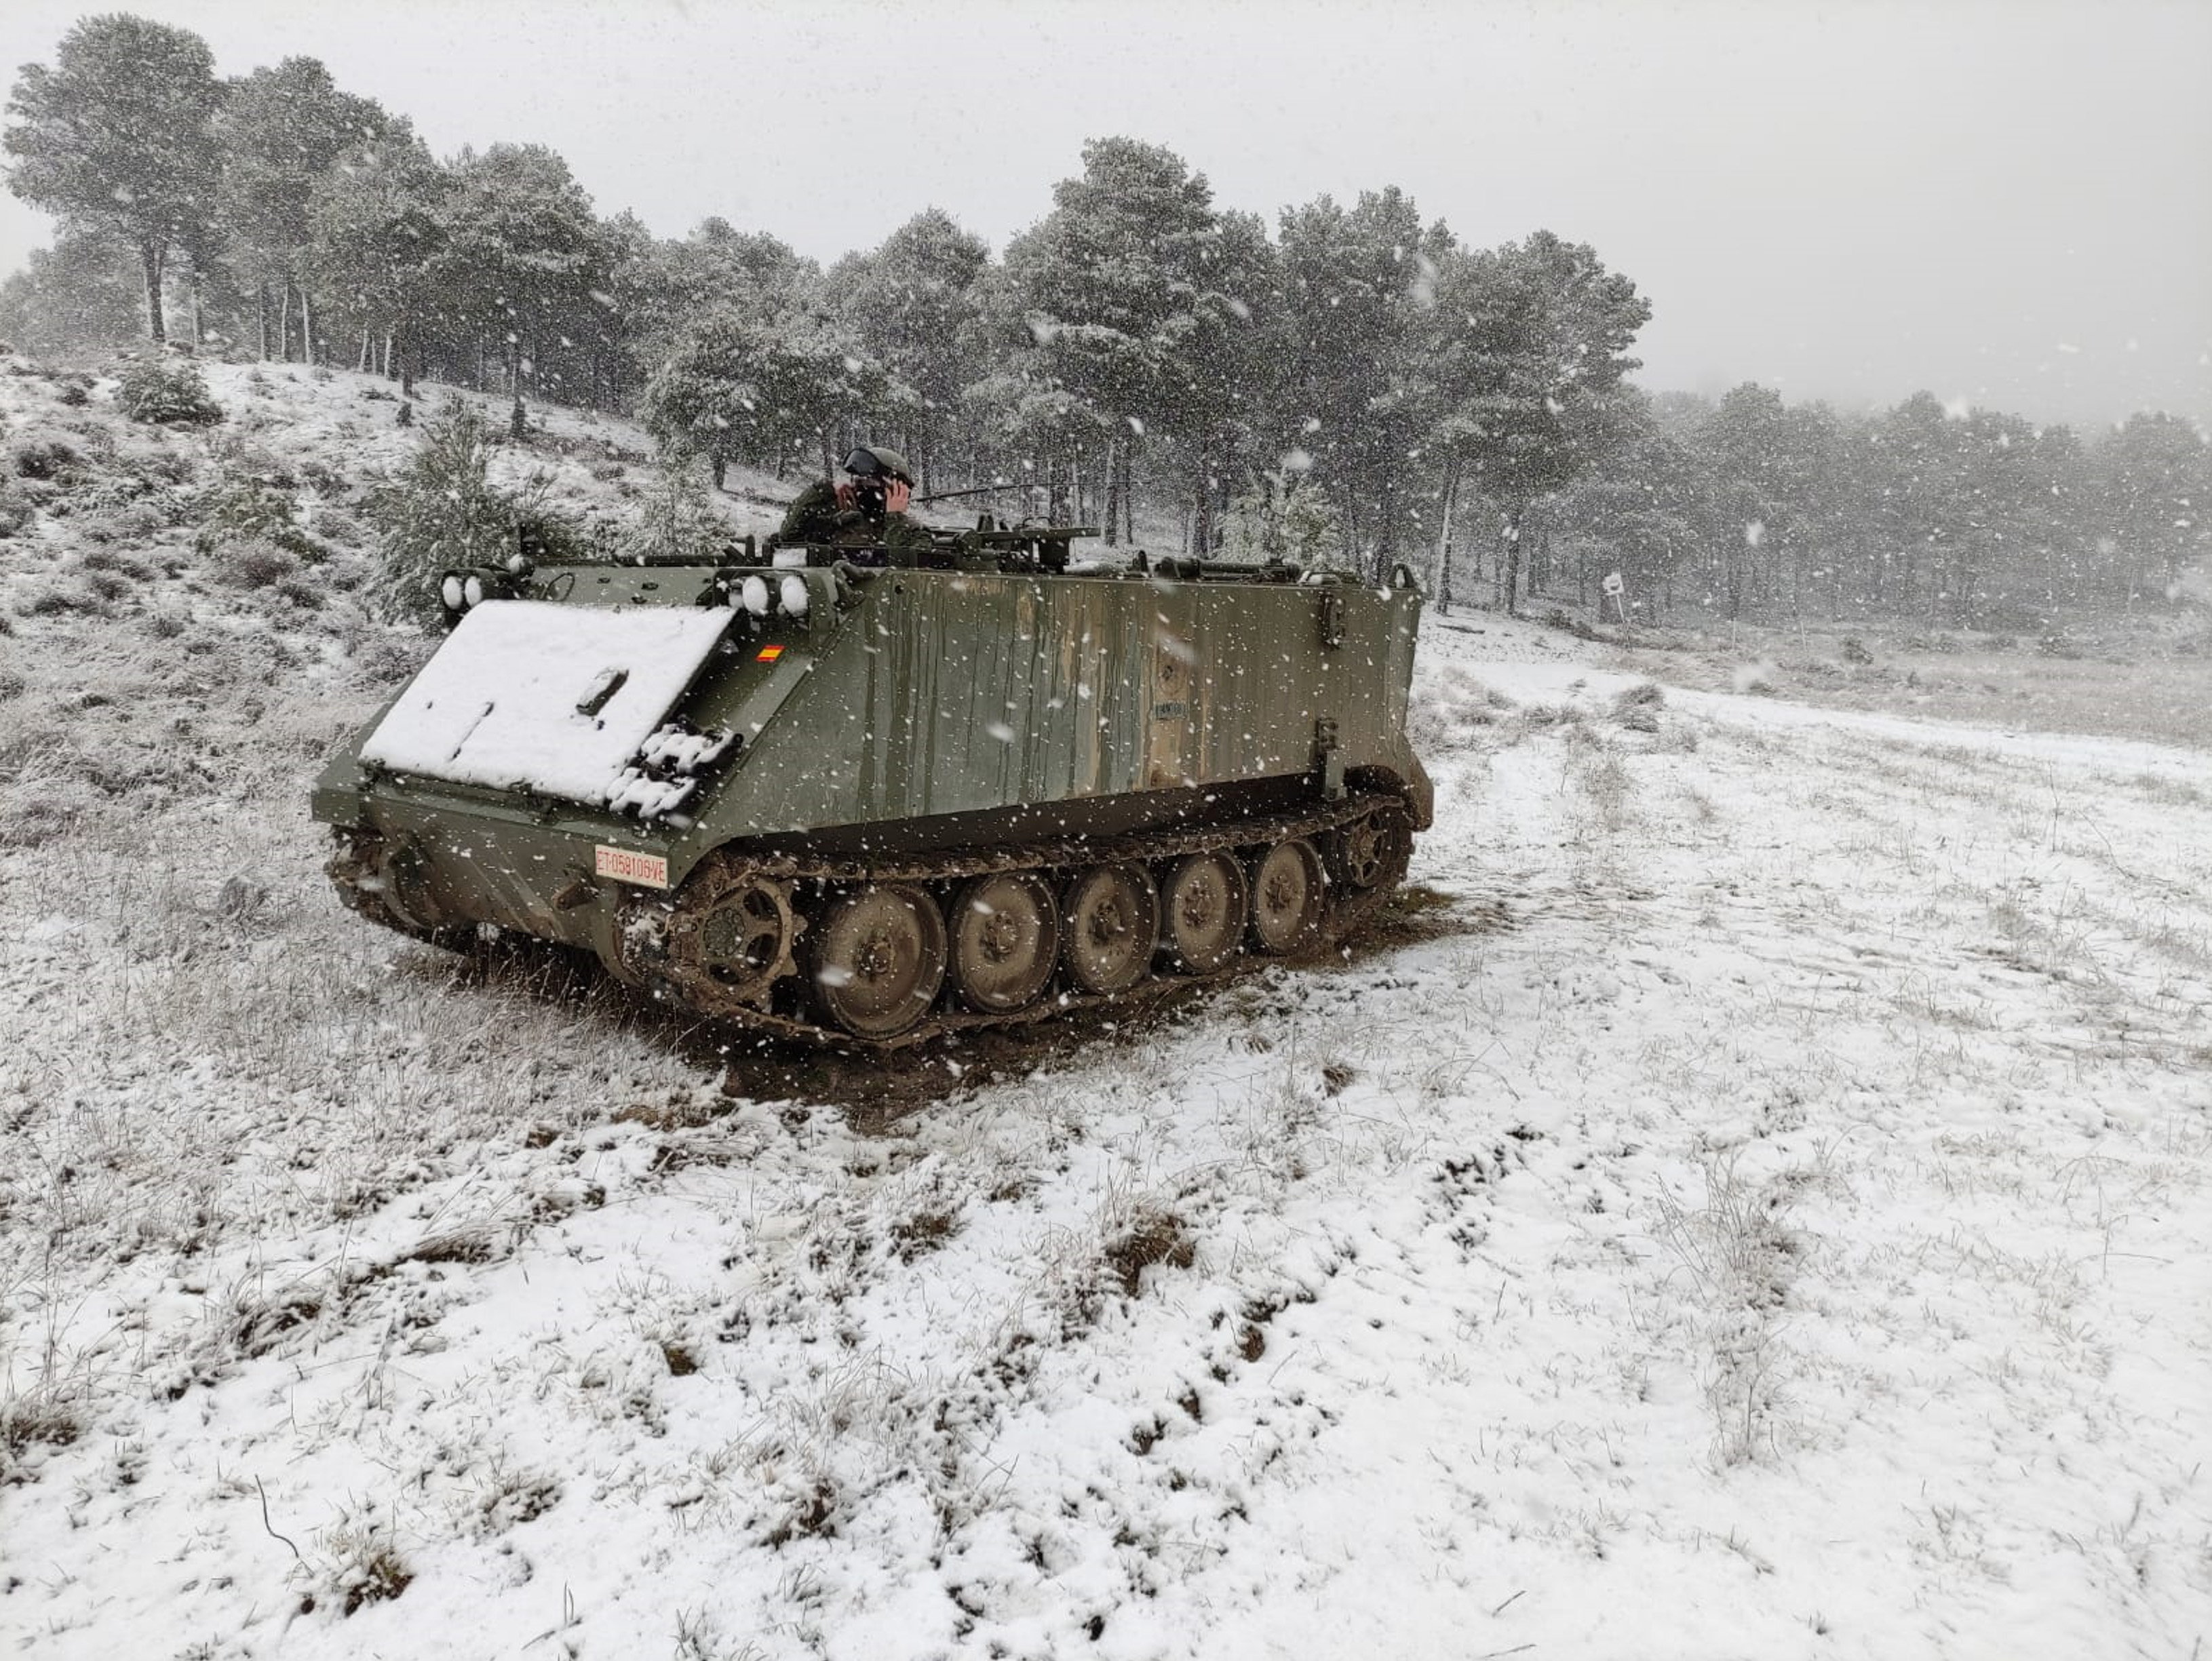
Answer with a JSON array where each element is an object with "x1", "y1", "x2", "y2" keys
[{"x1": 0, "y1": 16, "x2": 2212, "y2": 626}]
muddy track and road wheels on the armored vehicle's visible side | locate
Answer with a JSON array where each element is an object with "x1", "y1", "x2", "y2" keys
[{"x1": 621, "y1": 798, "x2": 1412, "y2": 1051}]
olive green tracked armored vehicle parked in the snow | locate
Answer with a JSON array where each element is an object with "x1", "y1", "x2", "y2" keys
[{"x1": 314, "y1": 522, "x2": 1431, "y2": 1049}]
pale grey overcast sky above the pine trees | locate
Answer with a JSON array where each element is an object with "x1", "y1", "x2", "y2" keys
[{"x1": 0, "y1": 0, "x2": 2212, "y2": 427}]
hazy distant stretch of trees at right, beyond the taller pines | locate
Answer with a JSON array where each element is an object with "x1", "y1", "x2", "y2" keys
[{"x1": 1540, "y1": 385, "x2": 2212, "y2": 633}]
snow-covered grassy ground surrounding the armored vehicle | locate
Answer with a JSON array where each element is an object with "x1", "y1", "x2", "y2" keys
[{"x1": 0, "y1": 358, "x2": 2212, "y2": 1661}]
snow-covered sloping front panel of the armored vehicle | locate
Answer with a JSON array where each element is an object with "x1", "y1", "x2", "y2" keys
[{"x1": 361, "y1": 600, "x2": 737, "y2": 803}]
